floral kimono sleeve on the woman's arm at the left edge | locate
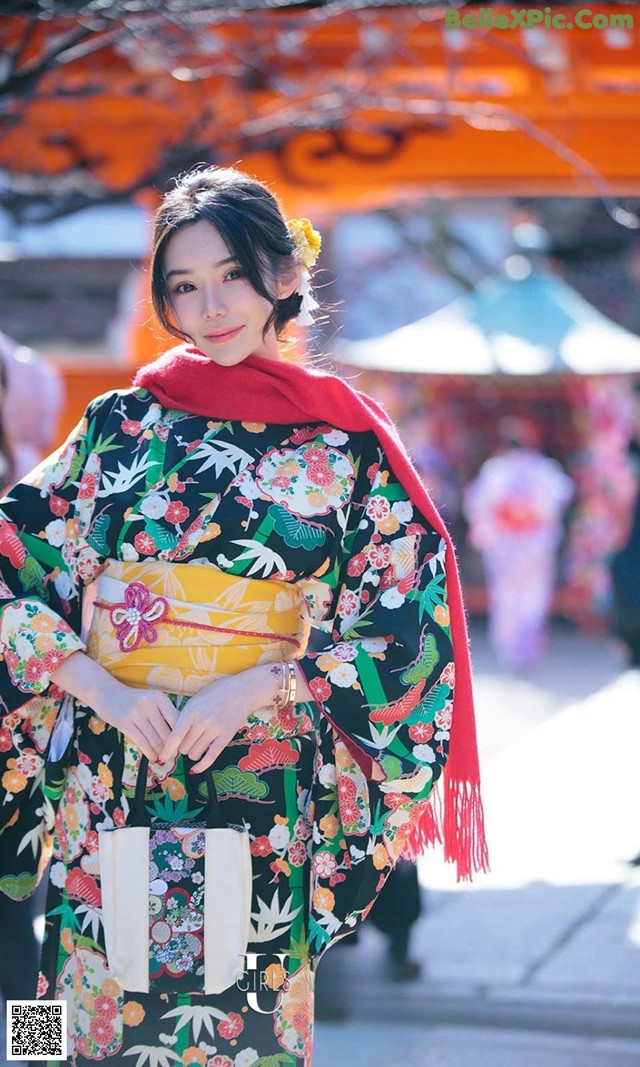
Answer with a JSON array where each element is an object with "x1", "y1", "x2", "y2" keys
[{"x1": 0, "y1": 390, "x2": 113, "y2": 714}]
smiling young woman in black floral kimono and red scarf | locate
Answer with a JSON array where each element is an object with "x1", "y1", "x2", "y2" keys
[{"x1": 0, "y1": 168, "x2": 486, "y2": 1067}]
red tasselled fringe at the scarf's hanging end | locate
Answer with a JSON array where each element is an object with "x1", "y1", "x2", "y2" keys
[{"x1": 403, "y1": 773, "x2": 490, "y2": 881}]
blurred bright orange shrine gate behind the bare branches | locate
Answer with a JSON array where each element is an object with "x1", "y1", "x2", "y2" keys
[{"x1": 0, "y1": 0, "x2": 640, "y2": 428}]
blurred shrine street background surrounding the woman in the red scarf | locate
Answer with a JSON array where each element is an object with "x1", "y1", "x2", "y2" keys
[{"x1": 0, "y1": 0, "x2": 640, "y2": 1067}]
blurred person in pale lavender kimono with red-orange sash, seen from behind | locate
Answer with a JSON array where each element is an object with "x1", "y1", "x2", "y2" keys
[{"x1": 464, "y1": 416, "x2": 574, "y2": 671}]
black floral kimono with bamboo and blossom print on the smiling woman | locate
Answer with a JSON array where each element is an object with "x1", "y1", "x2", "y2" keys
[{"x1": 0, "y1": 388, "x2": 454, "y2": 1067}]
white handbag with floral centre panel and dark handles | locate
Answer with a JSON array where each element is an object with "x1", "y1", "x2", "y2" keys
[{"x1": 98, "y1": 757, "x2": 252, "y2": 993}]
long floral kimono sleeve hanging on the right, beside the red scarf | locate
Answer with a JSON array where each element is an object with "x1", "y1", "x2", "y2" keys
[{"x1": 300, "y1": 439, "x2": 454, "y2": 954}]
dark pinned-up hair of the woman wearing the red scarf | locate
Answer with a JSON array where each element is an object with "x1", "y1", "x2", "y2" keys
[{"x1": 150, "y1": 166, "x2": 302, "y2": 340}]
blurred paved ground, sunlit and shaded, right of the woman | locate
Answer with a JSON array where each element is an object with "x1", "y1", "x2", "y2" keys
[{"x1": 316, "y1": 625, "x2": 640, "y2": 1067}]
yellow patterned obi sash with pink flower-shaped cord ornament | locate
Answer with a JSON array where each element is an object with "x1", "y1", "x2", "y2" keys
[{"x1": 86, "y1": 560, "x2": 309, "y2": 696}]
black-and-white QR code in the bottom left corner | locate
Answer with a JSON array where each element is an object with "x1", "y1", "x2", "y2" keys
[{"x1": 6, "y1": 1000, "x2": 67, "y2": 1060}]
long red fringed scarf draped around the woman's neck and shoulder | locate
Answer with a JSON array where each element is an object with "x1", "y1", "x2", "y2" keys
[{"x1": 133, "y1": 345, "x2": 489, "y2": 879}]
